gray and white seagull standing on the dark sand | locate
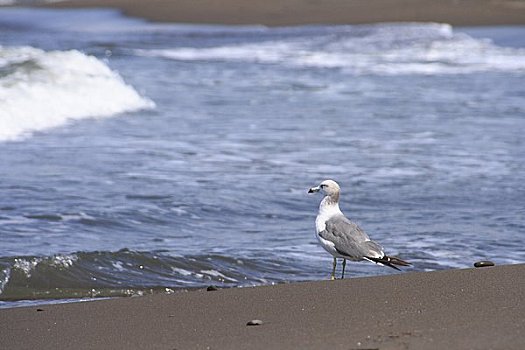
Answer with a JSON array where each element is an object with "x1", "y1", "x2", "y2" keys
[{"x1": 308, "y1": 180, "x2": 410, "y2": 280}]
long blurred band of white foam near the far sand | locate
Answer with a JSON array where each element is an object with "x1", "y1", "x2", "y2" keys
[{"x1": 136, "y1": 23, "x2": 525, "y2": 75}]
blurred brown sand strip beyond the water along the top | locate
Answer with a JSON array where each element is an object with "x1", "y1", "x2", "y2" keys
[{"x1": 45, "y1": 0, "x2": 525, "y2": 26}]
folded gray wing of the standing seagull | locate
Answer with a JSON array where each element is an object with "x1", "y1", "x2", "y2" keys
[{"x1": 319, "y1": 215, "x2": 384, "y2": 260}]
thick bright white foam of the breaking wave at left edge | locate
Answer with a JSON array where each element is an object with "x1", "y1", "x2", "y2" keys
[{"x1": 0, "y1": 46, "x2": 154, "y2": 141}]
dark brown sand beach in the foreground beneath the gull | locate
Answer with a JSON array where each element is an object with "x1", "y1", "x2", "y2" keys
[{"x1": 0, "y1": 265, "x2": 525, "y2": 350}]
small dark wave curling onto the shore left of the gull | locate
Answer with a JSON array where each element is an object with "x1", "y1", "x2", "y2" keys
[{"x1": 0, "y1": 249, "x2": 308, "y2": 301}]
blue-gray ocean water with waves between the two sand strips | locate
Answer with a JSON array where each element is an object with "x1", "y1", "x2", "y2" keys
[{"x1": 0, "y1": 8, "x2": 525, "y2": 307}]
